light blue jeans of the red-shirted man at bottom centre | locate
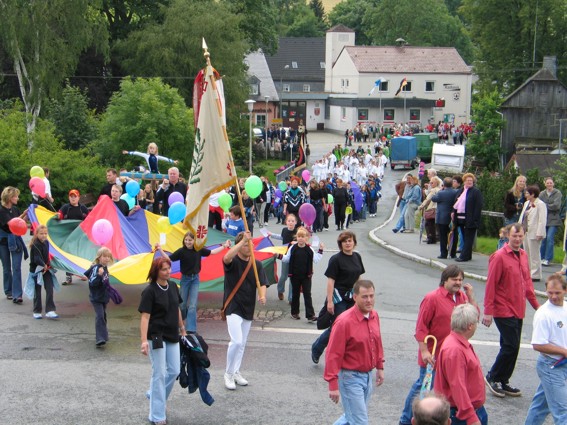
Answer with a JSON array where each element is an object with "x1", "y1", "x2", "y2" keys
[{"x1": 335, "y1": 369, "x2": 373, "y2": 425}]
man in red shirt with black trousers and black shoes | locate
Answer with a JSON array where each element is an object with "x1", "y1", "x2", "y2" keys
[{"x1": 482, "y1": 223, "x2": 539, "y2": 397}]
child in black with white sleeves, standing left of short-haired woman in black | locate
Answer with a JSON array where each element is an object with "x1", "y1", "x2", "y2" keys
[{"x1": 282, "y1": 227, "x2": 325, "y2": 323}]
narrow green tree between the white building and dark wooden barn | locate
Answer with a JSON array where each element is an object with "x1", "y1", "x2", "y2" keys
[{"x1": 467, "y1": 90, "x2": 504, "y2": 171}]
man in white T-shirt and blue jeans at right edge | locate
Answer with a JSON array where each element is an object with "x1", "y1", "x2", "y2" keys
[{"x1": 526, "y1": 274, "x2": 567, "y2": 425}]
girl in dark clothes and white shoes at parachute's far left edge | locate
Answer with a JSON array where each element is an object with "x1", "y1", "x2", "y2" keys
[{"x1": 26, "y1": 224, "x2": 59, "y2": 319}]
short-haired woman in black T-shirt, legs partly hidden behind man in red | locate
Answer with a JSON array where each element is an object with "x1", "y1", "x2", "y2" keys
[{"x1": 311, "y1": 230, "x2": 365, "y2": 364}]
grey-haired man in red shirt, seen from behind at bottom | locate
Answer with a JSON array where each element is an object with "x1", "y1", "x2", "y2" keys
[{"x1": 434, "y1": 304, "x2": 488, "y2": 425}]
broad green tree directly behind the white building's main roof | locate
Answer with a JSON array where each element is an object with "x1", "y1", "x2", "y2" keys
[{"x1": 362, "y1": 0, "x2": 473, "y2": 63}]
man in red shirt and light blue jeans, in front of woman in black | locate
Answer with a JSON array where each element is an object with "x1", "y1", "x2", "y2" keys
[{"x1": 324, "y1": 280, "x2": 384, "y2": 424}]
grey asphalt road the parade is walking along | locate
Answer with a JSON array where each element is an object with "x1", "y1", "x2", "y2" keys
[{"x1": 0, "y1": 133, "x2": 551, "y2": 425}]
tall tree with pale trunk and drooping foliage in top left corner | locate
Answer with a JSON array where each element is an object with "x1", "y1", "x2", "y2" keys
[{"x1": 0, "y1": 0, "x2": 108, "y2": 142}]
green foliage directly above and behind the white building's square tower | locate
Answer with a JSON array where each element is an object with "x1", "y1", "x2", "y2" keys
[{"x1": 327, "y1": 0, "x2": 379, "y2": 46}]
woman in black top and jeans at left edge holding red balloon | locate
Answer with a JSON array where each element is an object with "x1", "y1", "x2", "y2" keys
[{"x1": 0, "y1": 186, "x2": 28, "y2": 304}]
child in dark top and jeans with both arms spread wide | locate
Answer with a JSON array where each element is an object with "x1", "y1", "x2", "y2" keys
[{"x1": 156, "y1": 232, "x2": 230, "y2": 333}]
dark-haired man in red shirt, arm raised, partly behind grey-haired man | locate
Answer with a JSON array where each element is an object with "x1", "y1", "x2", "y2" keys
[{"x1": 400, "y1": 264, "x2": 478, "y2": 425}]
